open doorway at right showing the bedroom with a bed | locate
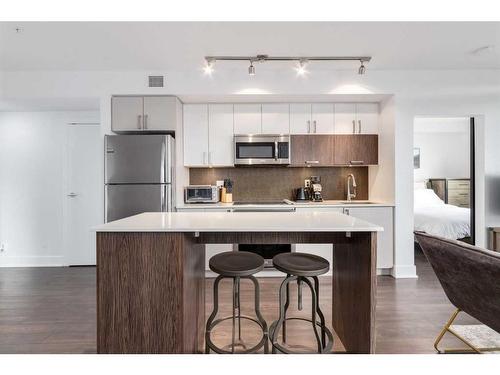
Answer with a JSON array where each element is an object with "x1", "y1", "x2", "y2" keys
[{"x1": 413, "y1": 117, "x2": 476, "y2": 244}]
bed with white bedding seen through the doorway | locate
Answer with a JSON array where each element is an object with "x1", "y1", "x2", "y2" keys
[{"x1": 413, "y1": 186, "x2": 470, "y2": 240}]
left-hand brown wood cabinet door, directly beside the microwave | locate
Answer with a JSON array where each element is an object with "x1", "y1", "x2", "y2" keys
[{"x1": 291, "y1": 134, "x2": 334, "y2": 167}]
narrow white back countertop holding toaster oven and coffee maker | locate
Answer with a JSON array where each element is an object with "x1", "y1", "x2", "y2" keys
[{"x1": 177, "y1": 200, "x2": 394, "y2": 210}]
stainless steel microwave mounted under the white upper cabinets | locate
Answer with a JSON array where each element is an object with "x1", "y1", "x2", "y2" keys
[{"x1": 234, "y1": 134, "x2": 290, "y2": 165}]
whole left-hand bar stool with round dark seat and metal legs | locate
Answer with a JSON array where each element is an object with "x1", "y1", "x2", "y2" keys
[{"x1": 205, "y1": 251, "x2": 269, "y2": 354}]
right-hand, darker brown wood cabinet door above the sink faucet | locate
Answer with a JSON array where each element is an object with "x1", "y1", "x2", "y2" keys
[{"x1": 333, "y1": 134, "x2": 378, "y2": 165}]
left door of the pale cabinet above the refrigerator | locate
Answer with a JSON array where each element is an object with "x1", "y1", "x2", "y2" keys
[{"x1": 111, "y1": 96, "x2": 144, "y2": 131}]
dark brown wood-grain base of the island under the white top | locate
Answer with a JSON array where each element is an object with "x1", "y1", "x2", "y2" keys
[{"x1": 97, "y1": 232, "x2": 377, "y2": 353}]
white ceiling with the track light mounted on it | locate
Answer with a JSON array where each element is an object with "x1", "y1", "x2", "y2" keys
[{"x1": 0, "y1": 22, "x2": 500, "y2": 71}]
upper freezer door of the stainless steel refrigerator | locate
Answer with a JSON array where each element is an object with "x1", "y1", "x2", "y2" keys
[{"x1": 105, "y1": 134, "x2": 174, "y2": 184}]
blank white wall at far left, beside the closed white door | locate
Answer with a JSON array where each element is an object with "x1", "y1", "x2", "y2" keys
[{"x1": 0, "y1": 112, "x2": 99, "y2": 266}]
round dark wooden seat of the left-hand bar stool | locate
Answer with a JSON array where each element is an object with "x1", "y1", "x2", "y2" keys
[{"x1": 208, "y1": 251, "x2": 264, "y2": 277}]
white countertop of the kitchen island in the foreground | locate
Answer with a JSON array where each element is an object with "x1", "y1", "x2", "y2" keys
[{"x1": 94, "y1": 211, "x2": 384, "y2": 232}]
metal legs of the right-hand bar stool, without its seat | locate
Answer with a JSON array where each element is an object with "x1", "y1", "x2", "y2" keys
[{"x1": 269, "y1": 275, "x2": 333, "y2": 353}]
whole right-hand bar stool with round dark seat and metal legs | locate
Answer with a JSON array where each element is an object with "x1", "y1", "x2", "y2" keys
[{"x1": 269, "y1": 253, "x2": 333, "y2": 354}]
